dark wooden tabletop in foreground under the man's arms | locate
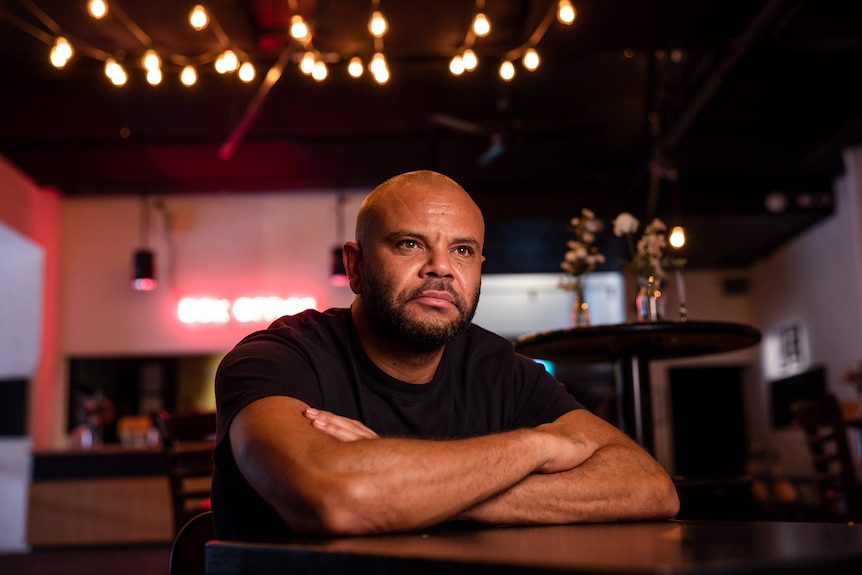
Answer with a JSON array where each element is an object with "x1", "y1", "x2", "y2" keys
[{"x1": 206, "y1": 521, "x2": 862, "y2": 575}]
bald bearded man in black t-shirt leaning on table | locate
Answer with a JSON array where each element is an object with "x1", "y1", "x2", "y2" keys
[{"x1": 213, "y1": 171, "x2": 679, "y2": 540}]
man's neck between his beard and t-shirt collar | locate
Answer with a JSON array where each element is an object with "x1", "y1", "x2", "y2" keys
[{"x1": 351, "y1": 303, "x2": 444, "y2": 384}]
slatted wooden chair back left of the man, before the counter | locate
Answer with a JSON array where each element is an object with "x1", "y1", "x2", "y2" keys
[{"x1": 153, "y1": 411, "x2": 216, "y2": 534}]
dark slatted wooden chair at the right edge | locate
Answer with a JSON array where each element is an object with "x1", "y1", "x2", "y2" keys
[{"x1": 791, "y1": 394, "x2": 862, "y2": 522}]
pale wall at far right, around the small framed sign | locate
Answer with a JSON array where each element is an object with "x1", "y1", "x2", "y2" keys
[{"x1": 751, "y1": 149, "x2": 862, "y2": 473}]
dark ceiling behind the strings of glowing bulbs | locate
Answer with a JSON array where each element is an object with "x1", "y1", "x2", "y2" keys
[{"x1": 0, "y1": 0, "x2": 862, "y2": 271}]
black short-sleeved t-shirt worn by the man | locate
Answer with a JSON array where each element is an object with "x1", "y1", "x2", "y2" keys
[{"x1": 212, "y1": 309, "x2": 581, "y2": 540}]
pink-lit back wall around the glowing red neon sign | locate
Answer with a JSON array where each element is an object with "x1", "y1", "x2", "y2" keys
[{"x1": 61, "y1": 190, "x2": 367, "y2": 356}]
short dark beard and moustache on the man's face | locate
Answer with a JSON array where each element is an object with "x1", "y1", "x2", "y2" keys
[{"x1": 362, "y1": 273, "x2": 481, "y2": 353}]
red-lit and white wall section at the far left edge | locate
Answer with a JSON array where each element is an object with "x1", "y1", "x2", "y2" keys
[{"x1": 0, "y1": 157, "x2": 59, "y2": 551}]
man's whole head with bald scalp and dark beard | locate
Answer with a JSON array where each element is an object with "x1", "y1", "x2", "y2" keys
[{"x1": 345, "y1": 171, "x2": 485, "y2": 352}]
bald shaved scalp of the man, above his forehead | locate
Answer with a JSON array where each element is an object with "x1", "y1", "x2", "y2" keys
[{"x1": 356, "y1": 170, "x2": 485, "y2": 245}]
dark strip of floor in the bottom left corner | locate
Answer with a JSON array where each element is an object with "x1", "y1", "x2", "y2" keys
[{"x1": 0, "y1": 545, "x2": 170, "y2": 575}]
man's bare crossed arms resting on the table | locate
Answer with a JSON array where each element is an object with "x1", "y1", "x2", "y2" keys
[{"x1": 230, "y1": 396, "x2": 679, "y2": 534}]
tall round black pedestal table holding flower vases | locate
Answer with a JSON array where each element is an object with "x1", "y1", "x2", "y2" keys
[{"x1": 515, "y1": 321, "x2": 760, "y2": 452}]
